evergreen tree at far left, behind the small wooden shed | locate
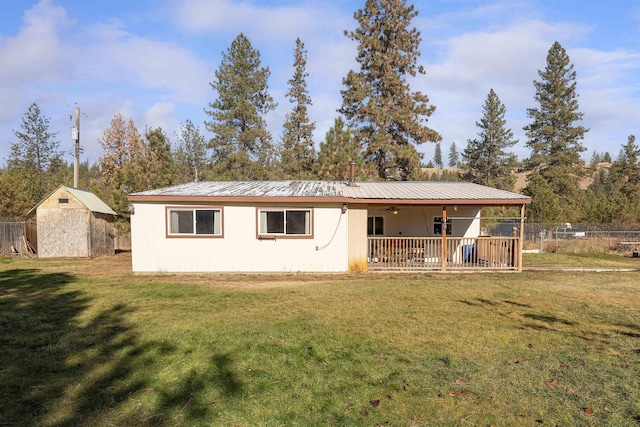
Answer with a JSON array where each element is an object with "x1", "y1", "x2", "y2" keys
[{"x1": 7, "y1": 103, "x2": 62, "y2": 205}]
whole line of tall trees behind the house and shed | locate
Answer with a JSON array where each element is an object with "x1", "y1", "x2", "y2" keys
[{"x1": 0, "y1": 0, "x2": 640, "y2": 227}]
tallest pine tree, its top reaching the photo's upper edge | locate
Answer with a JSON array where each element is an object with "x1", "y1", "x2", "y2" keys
[{"x1": 339, "y1": 0, "x2": 440, "y2": 180}]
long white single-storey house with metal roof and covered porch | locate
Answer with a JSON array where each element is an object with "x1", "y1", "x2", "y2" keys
[{"x1": 129, "y1": 181, "x2": 531, "y2": 272}]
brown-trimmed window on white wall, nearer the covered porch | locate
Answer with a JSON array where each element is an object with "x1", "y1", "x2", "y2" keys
[{"x1": 258, "y1": 209, "x2": 312, "y2": 236}]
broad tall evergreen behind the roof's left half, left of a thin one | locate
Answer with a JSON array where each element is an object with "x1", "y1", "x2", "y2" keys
[{"x1": 205, "y1": 33, "x2": 276, "y2": 180}]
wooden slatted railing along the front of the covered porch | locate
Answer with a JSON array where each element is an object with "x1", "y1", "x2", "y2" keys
[{"x1": 368, "y1": 237, "x2": 520, "y2": 271}]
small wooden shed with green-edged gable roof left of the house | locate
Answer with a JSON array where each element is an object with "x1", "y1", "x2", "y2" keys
[{"x1": 29, "y1": 185, "x2": 117, "y2": 258}]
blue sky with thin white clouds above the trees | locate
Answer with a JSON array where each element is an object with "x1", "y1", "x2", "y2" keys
[{"x1": 0, "y1": 0, "x2": 640, "y2": 165}]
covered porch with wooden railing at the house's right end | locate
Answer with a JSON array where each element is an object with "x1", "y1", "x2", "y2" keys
[{"x1": 358, "y1": 203, "x2": 525, "y2": 272}]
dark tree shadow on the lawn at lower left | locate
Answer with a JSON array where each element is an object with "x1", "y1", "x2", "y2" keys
[{"x1": 0, "y1": 270, "x2": 241, "y2": 426}]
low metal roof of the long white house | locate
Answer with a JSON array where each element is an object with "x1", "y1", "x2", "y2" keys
[{"x1": 129, "y1": 181, "x2": 531, "y2": 204}]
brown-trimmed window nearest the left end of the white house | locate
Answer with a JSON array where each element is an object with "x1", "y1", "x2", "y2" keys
[{"x1": 167, "y1": 208, "x2": 222, "y2": 237}]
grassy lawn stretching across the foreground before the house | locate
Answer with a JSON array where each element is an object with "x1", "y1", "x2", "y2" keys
[{"x1": 0, "y1": 255, "x2": 640, "y2": 426}]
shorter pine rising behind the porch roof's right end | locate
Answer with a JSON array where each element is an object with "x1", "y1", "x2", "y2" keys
[{"x1": 462, "y1": 89, "x2": 518, "y2": 190}]
